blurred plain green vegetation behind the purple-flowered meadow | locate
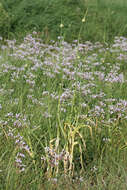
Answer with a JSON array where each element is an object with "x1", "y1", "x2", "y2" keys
[{"x1": 0, "y1": 0, "x2": 127, "y2": 42}]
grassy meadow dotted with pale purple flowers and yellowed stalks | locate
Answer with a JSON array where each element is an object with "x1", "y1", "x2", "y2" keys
[{"x1": 0, "y1": 32, "x2": 127, "y2": 190}]
